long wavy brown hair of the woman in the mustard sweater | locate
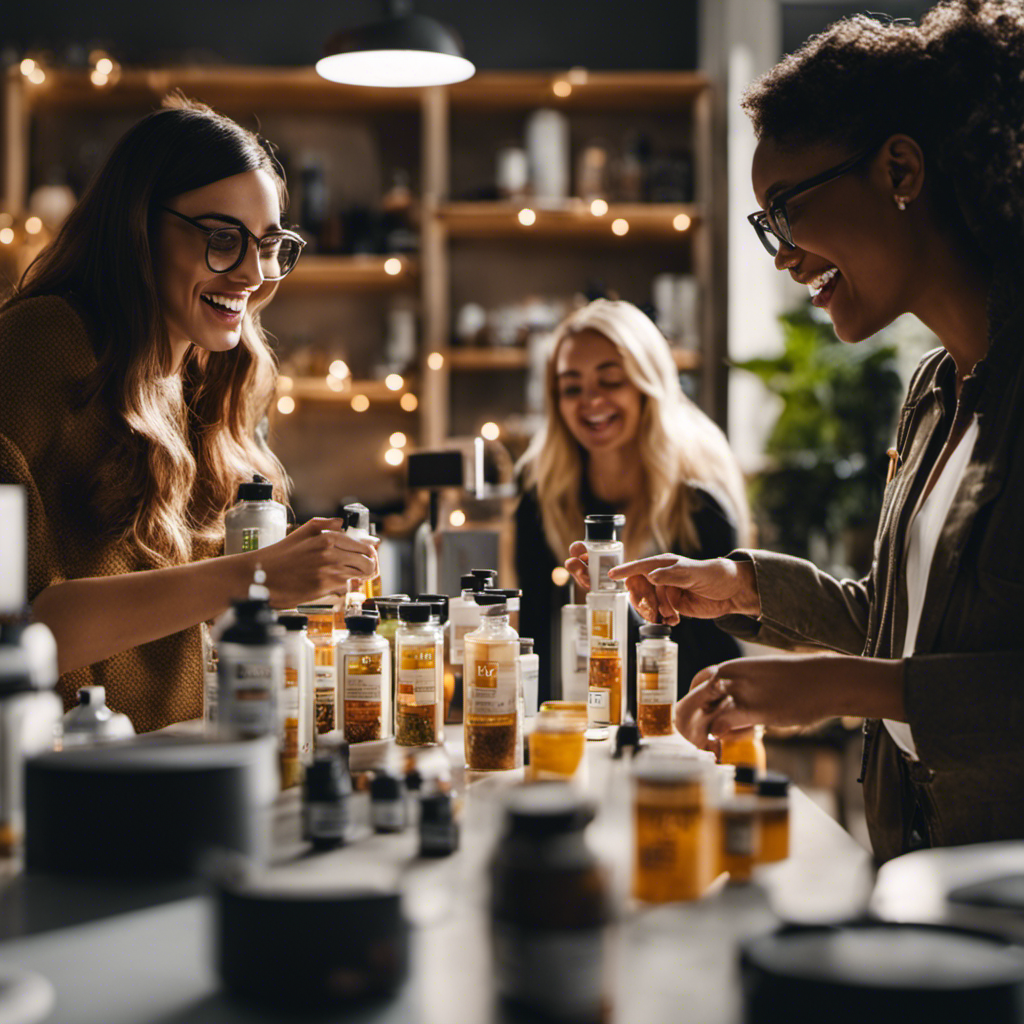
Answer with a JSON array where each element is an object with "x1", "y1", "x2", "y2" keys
[{"x1": 0, "y1": 93, "x2": 288, "y2": 566}]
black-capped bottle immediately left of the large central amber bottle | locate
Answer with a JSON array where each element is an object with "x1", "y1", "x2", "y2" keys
[{"x1": 394, "y1": 601, "x2": 444, "y2": 746}]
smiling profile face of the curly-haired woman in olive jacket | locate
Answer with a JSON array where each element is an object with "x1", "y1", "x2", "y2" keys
[{"x1": 753, "y1": 136, "x2": 922, "y2": 342}]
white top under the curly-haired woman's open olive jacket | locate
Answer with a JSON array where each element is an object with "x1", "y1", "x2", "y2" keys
[{"x1": 884, "y1": 417, "x2": 978, "y2": 761}]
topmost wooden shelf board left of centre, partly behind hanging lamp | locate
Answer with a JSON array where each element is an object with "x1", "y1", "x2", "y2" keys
[{"x1": 19, "y1": 67, "x2": 422, "y2": 112}]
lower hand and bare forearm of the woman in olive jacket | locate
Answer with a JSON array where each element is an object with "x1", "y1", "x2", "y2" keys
[{"x1": 675, "y1": 654, "x2": 905, "y2": 752}]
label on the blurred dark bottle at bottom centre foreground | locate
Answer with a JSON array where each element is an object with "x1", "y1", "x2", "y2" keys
[{"x1": 493, "y1": 922, "x2": 609, "y2": 1021}]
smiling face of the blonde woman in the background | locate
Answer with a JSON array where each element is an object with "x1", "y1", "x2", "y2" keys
[{"x1": 555, "y1": 331, "x2": 643, "y2": 453}]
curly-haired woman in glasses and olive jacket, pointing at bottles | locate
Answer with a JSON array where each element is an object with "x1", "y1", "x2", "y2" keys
[{"x1": 566, "y1": 0, "x2": 1024, "y2": 860}]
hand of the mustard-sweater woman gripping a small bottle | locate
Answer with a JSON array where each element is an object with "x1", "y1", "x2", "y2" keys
[{"x1": 238, "y1": 518, "x2": 378, "y2": 608}]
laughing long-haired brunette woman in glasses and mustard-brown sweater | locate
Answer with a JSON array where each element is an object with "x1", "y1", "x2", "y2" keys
[{"x1": 0, "y1": 96, "x2": 376, "y2": 731}]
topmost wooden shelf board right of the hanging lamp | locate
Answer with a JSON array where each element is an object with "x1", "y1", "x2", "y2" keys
[{"x1": 447, "y1": 70, "x2": 711, "y2": 112}]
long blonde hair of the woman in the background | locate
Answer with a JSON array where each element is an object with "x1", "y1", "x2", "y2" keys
[{"x1": 519, "y1": 299, "x2": 751, "y2": 560}]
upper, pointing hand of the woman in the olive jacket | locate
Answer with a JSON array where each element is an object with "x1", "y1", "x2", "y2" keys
[{"x1": 602, "y1": 542, "x2": 761, "y2": 626}]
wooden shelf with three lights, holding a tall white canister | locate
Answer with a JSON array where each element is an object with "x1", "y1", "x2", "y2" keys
[{"x1": 437, "y1": 200, "x2": 701, "y2": 245}]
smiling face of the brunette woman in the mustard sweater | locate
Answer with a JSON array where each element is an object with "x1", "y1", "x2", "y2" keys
[{"x1": 156, "y1": 170, "x2": 281, "y2": 366}]
